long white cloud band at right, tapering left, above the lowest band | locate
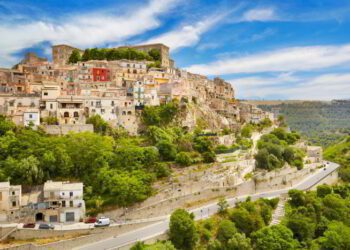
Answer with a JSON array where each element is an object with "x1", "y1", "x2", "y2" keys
[{"x1": 187, "y1": 44, "x2": 350, "y2": 75}]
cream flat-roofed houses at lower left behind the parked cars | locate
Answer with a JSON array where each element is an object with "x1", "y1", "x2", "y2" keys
[{"x1": 0, "y1": 181, "x2": 85, "y2": 223}]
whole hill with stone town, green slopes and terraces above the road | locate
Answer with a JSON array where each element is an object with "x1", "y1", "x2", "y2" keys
[{"x1": 0, "y1": 44, "x2": 332, "y2": 247}]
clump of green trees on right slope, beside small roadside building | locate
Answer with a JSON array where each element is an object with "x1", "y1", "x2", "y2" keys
[{"x1": 255, "y1": 128, "x2": 304, "y2": 170}]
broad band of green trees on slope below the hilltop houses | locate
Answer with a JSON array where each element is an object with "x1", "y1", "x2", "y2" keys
[{"x1": 0, "y1": 102, "x2": 230, "y2": 213}]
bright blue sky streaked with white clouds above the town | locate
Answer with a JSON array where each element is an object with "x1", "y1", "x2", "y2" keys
[{"x1": 0, "y1": 0, "x2": 350, "y2": 100}]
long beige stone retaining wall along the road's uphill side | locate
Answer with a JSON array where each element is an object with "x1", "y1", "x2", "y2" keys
[{"x1": 104, "y1": 165, "x2": 316, "y2": 219}]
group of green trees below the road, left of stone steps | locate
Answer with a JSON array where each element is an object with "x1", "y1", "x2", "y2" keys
[{"x1": 133, "y1": 199, "x2": 280, "y2": 250}]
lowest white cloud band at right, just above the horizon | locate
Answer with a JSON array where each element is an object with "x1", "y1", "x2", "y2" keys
[{"x1": 229, "y1": 73, "x2": 350, "y2": 100}]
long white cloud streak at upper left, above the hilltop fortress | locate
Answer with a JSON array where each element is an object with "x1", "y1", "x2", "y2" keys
[{"x1": 0, "y1": 0, "x2": 180, "y2": 66}]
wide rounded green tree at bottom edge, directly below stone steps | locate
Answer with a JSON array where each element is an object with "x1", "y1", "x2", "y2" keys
[{"x1": 251, "y1": 225, "x2": 298, "y2": 250}]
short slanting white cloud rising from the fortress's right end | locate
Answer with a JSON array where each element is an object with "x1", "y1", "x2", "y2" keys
[{"x1": 145, "y1": 13, "x2": 228, "y2": 50}]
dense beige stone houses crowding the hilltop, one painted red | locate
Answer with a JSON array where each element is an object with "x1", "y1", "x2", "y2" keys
[{"x1": 0, "y1": 44, "x2": 270, "y2": 134}]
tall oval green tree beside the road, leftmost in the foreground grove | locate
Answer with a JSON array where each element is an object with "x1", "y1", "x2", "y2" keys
[{"x1": 169, "y1": 209, "x2": 198, "y2": 250}]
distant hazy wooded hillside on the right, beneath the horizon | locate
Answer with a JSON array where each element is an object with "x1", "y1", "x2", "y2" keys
[{"x1": 259, "y1": 102, "x2": 350, "y2": 147}]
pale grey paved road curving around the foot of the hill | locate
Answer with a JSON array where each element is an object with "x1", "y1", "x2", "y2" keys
[{"x1": 76, "y1": 162, "x2": 339, "y2": 250}]
